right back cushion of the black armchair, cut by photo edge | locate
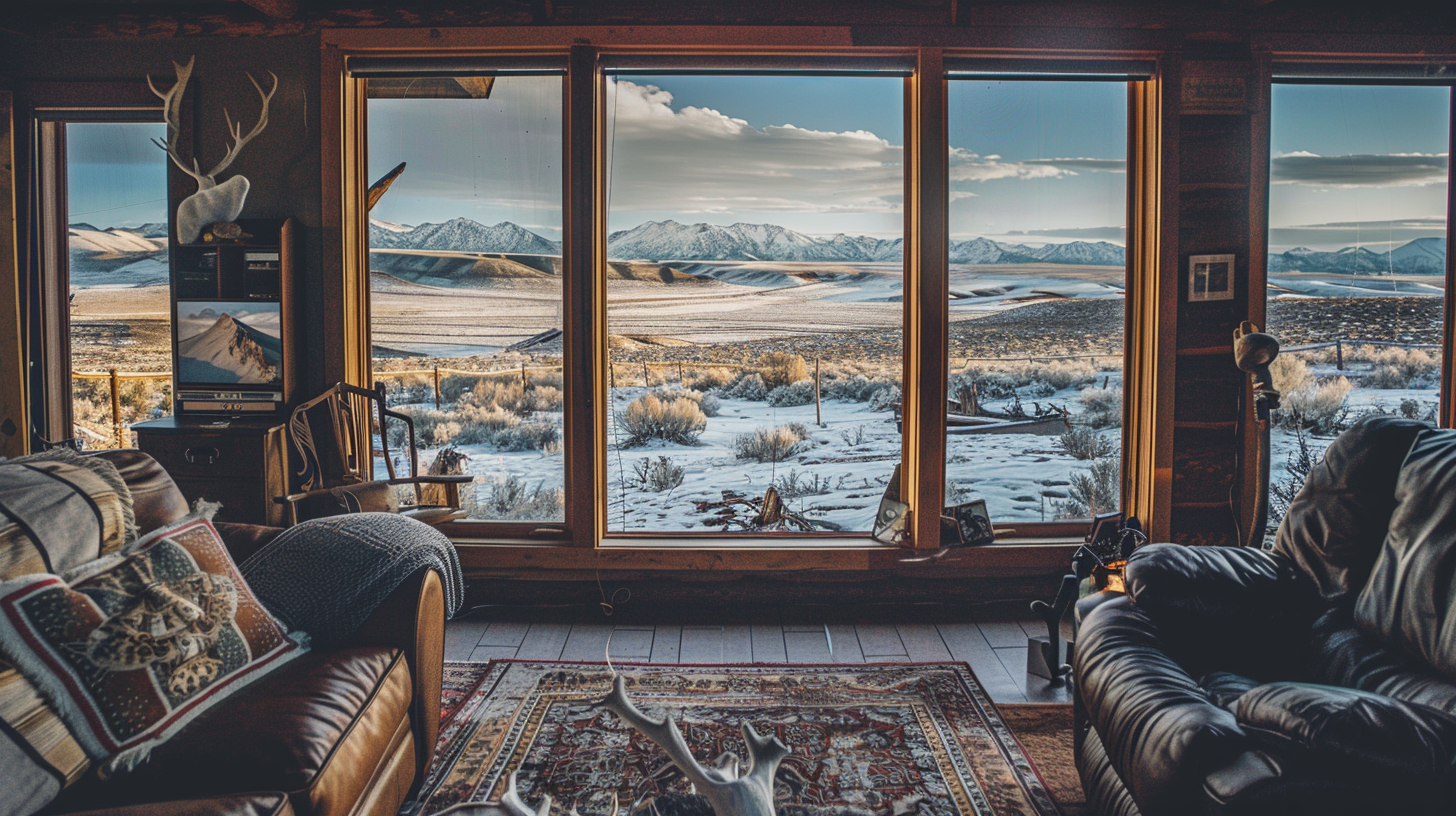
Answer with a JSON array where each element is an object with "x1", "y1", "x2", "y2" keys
[{"x1": 1354, "y1": 431, "x2": 1456, "y2": 680}]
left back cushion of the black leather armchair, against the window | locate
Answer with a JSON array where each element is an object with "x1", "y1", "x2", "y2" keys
[{"x1": 1274, "y1": 417, "x2": 1430, "y2": 603}]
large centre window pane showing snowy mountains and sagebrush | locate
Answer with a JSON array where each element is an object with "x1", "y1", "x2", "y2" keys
[{"x1": 607, "y1": 76, "x2": 904, "y2": 533}]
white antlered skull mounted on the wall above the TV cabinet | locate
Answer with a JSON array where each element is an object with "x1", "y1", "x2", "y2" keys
[{"x1": 147, "y1": 57, "x2": 278, "y2": 243}]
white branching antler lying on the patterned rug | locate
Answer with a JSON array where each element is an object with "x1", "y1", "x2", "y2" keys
[{"x1": 596, "y1": 675, "x2": 789, "y2": 816}]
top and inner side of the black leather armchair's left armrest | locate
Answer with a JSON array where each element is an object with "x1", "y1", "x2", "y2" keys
[{"x1": 1124, "y1": 544, "x2": 1321, "y2": 679}]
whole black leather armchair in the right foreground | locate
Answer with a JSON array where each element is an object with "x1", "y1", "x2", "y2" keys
[{"x1": 1073, "y1": 418, "x2": 1456, "y2": 816}]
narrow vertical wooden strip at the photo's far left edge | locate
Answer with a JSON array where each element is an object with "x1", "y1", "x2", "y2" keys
[{"x1": 0, "y1": 90, "x2": 22, "y2": 458}]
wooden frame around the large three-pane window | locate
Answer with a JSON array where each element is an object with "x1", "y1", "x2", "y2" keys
[{"x1": 320, "y1": 26, "x2": 1176, "y2": 570}]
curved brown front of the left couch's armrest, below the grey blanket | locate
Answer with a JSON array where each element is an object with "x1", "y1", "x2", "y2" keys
[{"x1": 347, "y1": 567, "x2": 446, "y2": 788}]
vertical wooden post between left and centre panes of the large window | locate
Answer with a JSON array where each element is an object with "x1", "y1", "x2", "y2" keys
[{"x1": 562, "y1": 45, "x2": 599, "y2": 548}]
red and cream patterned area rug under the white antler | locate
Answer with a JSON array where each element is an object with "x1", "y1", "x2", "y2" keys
[{"x1": 402, "y1": 660, "x2": 1061, "y2": 816}]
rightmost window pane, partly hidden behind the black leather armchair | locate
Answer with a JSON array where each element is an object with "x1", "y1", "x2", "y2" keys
[{"x1": 1267, "y1": 85, "x2": 1452, "y2": 532}]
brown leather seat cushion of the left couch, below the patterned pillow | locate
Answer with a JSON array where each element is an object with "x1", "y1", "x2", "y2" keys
[{"x1": 61, "y1": 647, "x2": 414, "y2": 815}]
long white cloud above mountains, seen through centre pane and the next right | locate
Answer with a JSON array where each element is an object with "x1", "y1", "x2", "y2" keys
[{"x1": 607, "y1": 80, "x2": 1083, "y2": 214}]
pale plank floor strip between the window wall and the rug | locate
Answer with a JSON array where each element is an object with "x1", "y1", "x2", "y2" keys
[{"x1": 446, "y1": 609, "x2": 1072, "y2": 702}]
